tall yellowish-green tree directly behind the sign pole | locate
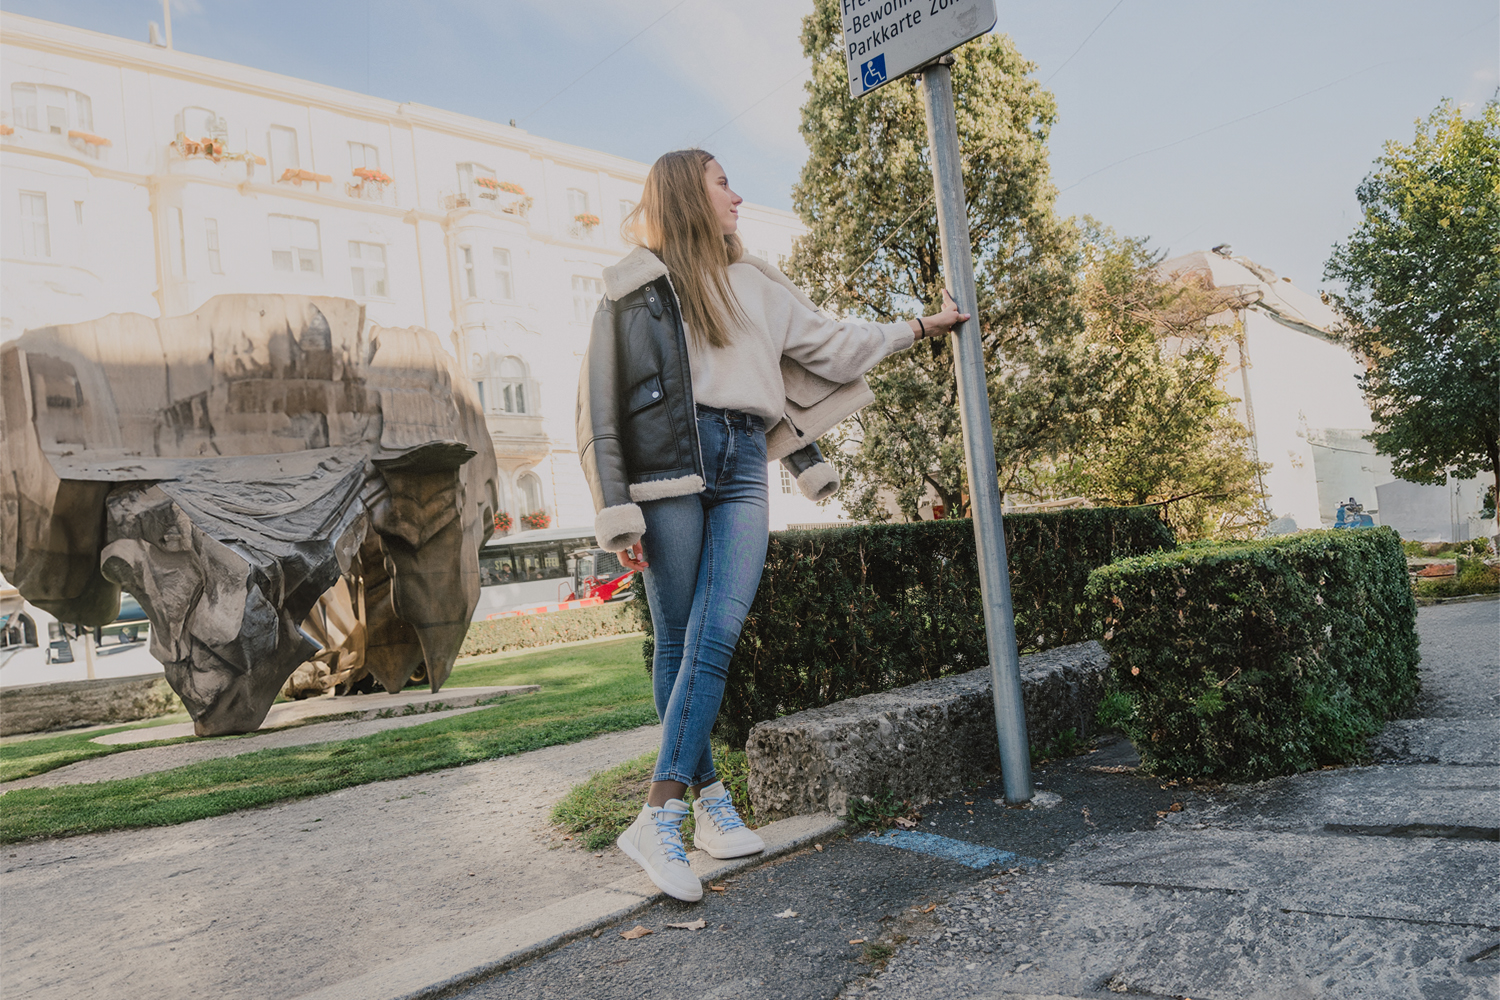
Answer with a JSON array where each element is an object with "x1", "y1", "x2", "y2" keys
[{"x1": 789, "y1": 0, "x2": 1079, "y2": 519}]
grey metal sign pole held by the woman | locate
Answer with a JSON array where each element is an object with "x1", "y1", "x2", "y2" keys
[{"x1": 921, "y1": 57, "x2": 1032, "y2": 802}]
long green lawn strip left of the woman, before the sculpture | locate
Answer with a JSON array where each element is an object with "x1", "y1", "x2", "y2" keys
[{"x1": 0, "y1": 637, "x2": 656, "y2": 843}]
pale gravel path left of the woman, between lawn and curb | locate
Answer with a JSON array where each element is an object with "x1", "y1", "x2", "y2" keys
[{"x1": 0, "y1": 709, "x2": 840, "y2": 1000}]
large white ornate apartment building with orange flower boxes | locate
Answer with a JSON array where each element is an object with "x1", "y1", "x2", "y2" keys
[{"x1": 0, "y1": 13, "x2": 842, "y2": 529}]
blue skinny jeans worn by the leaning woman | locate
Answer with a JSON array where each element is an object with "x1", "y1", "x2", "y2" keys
[{"x1": 641, "y1": 406, "x2": 771, "y2": 786}]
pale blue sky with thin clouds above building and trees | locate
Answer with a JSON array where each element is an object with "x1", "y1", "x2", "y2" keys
[{"x1": 11, "y1": 0, "x2": 1500, "y2": 291}]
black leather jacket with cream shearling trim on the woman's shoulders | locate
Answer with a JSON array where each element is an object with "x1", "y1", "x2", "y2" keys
[{"x1": 578, "y1": 247, "x2": 875, "y2": 552}]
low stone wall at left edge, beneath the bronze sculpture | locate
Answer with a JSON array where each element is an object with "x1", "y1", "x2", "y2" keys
[{"x1": 0, "y1": 673, "x2": 183, "y2": 736}]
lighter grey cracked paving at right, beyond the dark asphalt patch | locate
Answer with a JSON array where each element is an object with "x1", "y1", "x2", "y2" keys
[{"x1": 845, "y1": 601, "x2": 1500, "y2": 1000}]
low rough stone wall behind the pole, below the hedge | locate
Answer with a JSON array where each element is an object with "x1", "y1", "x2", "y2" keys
[{"x1": 746, "y1": 642, "x2": 1110, "y2": 820}]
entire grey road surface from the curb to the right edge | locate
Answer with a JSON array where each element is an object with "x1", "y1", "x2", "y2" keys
[{"x1": 449, "y1": 601, "x2": 1500, "y2": 1000}]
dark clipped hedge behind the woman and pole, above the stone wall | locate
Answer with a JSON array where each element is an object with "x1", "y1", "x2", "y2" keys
[{"x1": 638, "y1": 507, "x2": 1175, "y2": 747}]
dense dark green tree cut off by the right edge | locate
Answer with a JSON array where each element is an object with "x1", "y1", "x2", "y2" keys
[{"x1": 1325, "y1": 100, "x2": 1500, "y2": 515}]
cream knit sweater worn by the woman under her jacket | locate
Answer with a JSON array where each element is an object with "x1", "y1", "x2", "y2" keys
[{"x1": 687, "y1": 261, "x2": 912, "y2": 429}]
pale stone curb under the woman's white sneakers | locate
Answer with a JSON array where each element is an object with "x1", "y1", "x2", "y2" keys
[{"x1": 297, "y1": 813, "x2": 845, "y2": 1000}]
